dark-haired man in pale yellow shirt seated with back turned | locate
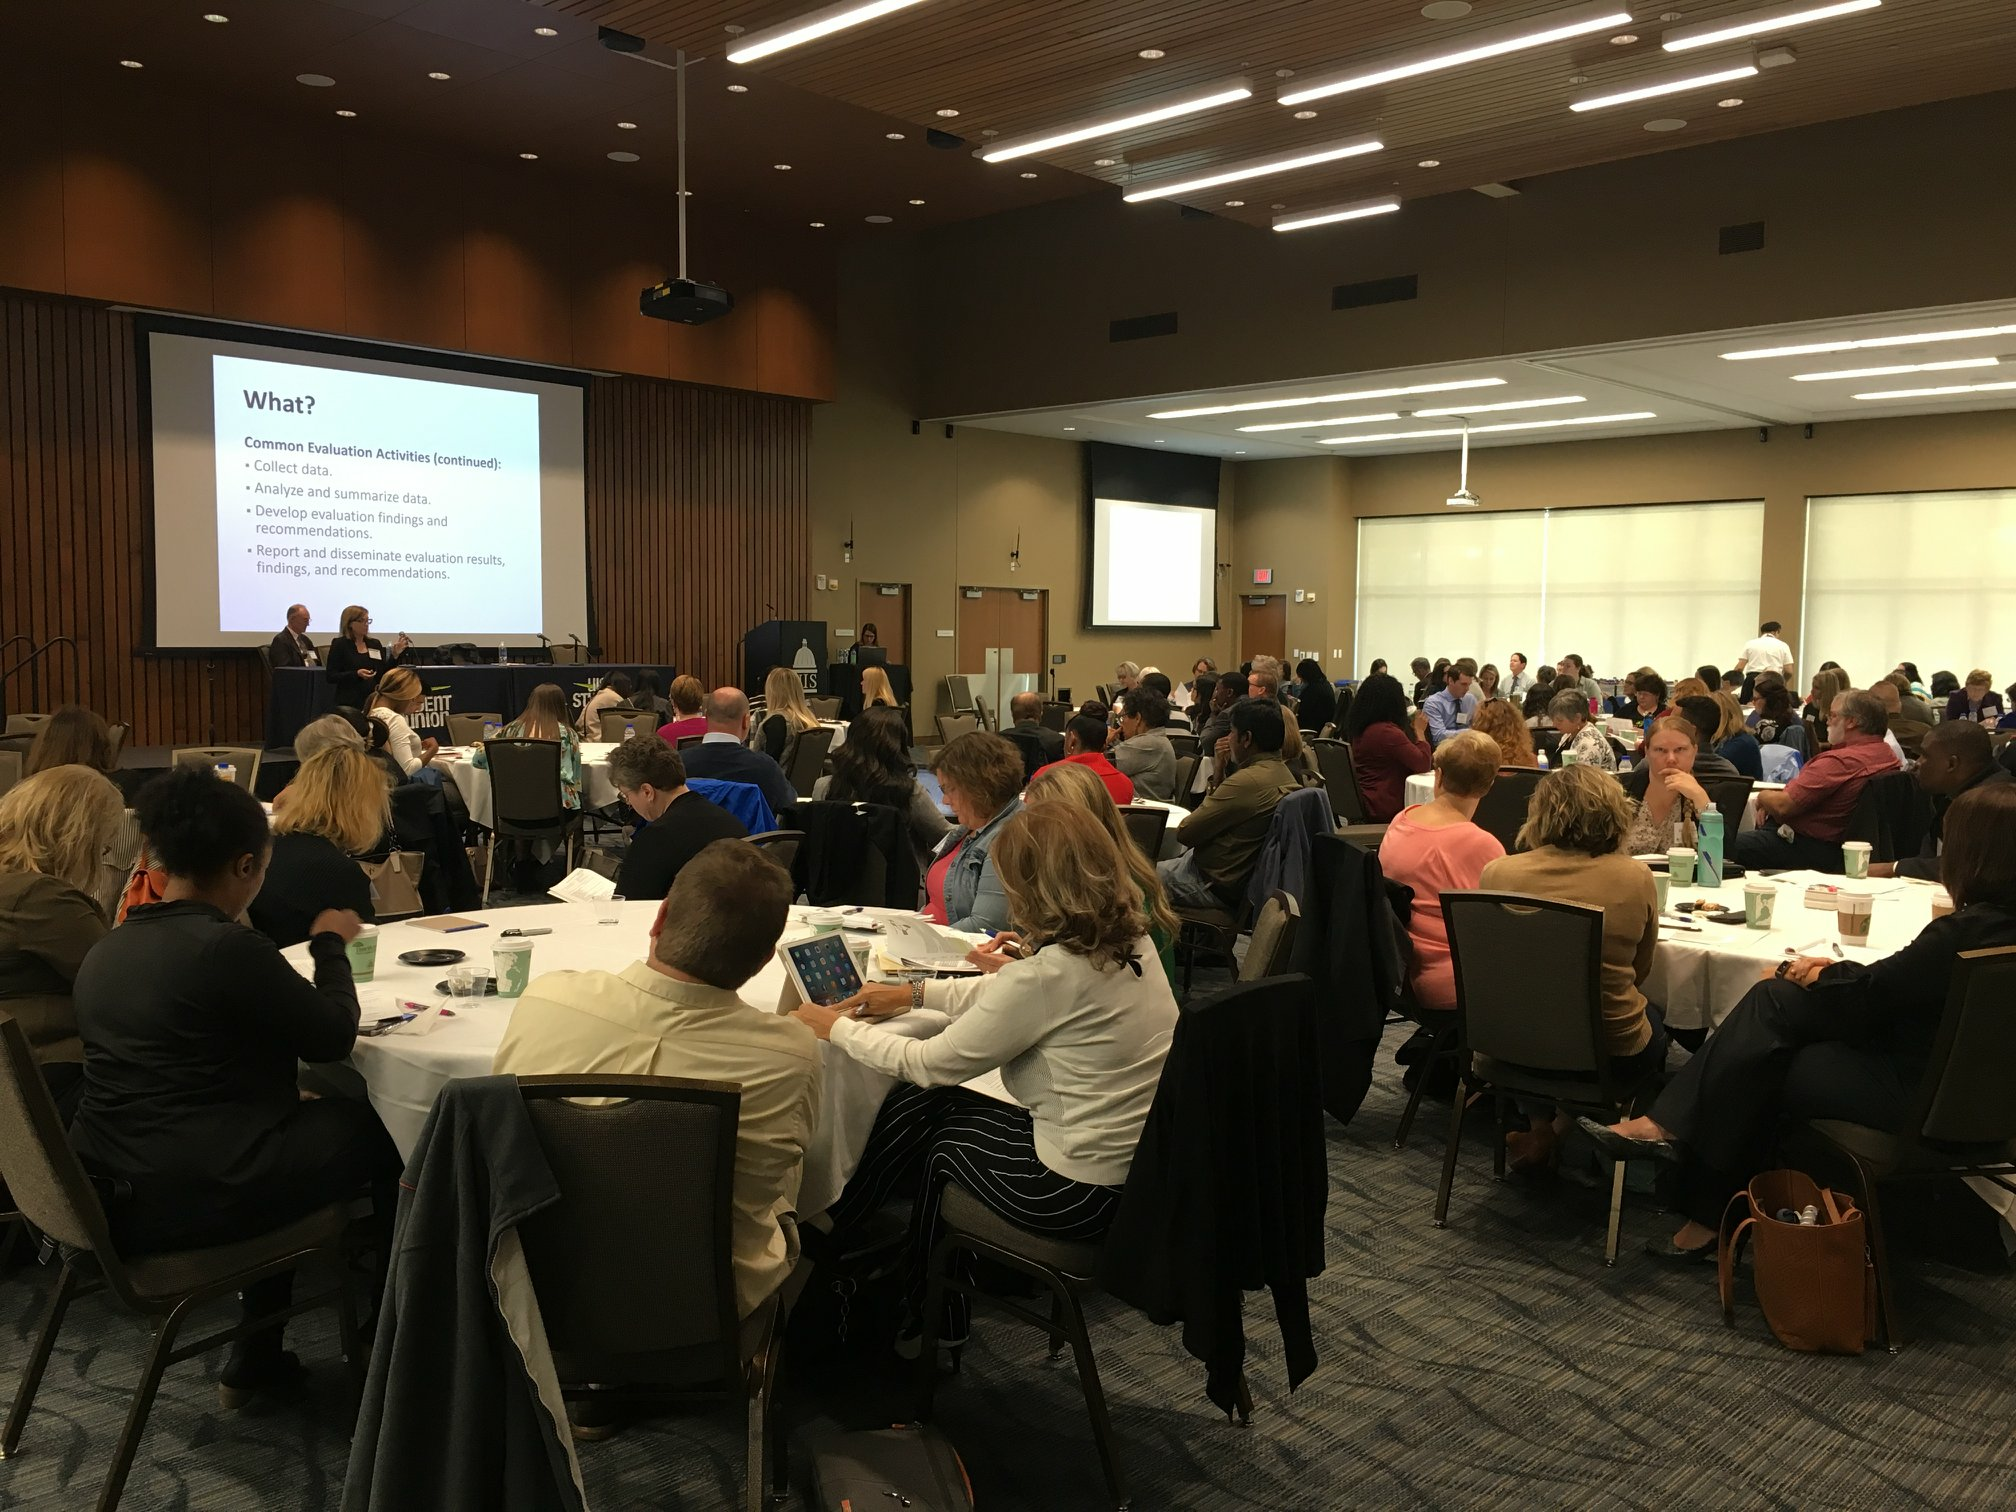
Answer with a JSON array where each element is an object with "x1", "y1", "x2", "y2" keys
[{"x1": 492, "y1": 834, "x2": 818, "y2": 1316}]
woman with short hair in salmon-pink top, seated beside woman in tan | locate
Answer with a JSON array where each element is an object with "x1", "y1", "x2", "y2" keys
[{"x1": 1379, "y1": 730, "x2": 1506, "y2": 1028}]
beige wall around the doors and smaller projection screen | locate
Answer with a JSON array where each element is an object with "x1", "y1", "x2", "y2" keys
[{"x1": 808, "y1": 246, "x2": 1238, "y2": 732}]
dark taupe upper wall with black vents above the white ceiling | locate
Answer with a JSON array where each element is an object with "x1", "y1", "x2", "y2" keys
[{"x1": 919, "y1": 93, "x2": 2016, "y2": 423}]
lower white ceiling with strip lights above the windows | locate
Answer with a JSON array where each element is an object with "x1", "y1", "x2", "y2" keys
[{"x1": 941, "y1": 300, "x2": 2016, "y2": 460}]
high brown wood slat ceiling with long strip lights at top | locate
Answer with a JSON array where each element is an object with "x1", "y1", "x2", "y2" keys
[{"x1": 546, "y1": 0, "x2": 2016, "y2": 224}]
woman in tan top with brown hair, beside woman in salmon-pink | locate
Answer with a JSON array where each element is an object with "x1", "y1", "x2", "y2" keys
[{"x1": 1482, "y1": 770, "x2": 1685, "y2": 1165}]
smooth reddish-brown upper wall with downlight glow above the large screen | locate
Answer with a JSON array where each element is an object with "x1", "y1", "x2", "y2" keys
[{"x1": 0, "y1": 69, "x2": 837, "y2": 399}]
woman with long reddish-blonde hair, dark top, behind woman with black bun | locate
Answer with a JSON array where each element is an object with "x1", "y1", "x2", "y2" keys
[{"x1": 246, "y1": 746, "x2": 391, "y2": 950}]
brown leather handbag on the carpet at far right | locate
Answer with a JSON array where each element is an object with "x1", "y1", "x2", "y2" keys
[{"x1": 1718, "y1": 1171, "x2": 1877, "y2": 1355}]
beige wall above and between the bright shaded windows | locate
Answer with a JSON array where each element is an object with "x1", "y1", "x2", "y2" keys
[{"x1": 1234, "y1": 411, "x2": 2016, "y2": 671}]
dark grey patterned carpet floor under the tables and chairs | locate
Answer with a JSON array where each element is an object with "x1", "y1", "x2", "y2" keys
[{"x1": 0, "y1": 1032, "x2": 2016, "y2": 1512}]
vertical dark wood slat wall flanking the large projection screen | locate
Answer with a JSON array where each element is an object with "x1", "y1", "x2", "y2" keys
[{"x1": 0, "y1": 290, "x2": 810, "y2": 744}]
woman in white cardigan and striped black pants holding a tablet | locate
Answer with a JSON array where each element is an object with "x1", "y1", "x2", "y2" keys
[{"x1": 796, "y1": 804, "x2": 1177, "y2": 1349}]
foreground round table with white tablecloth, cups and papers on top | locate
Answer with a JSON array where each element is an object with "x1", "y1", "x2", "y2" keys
[{"x1": 282, "y1": 899, "x2": 1014, "y2": 1216}]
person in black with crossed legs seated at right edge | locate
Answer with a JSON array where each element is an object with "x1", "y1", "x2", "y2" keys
[{"x1": 1585, "y1": 782, "x2": 2016, "y2": 1260}]
